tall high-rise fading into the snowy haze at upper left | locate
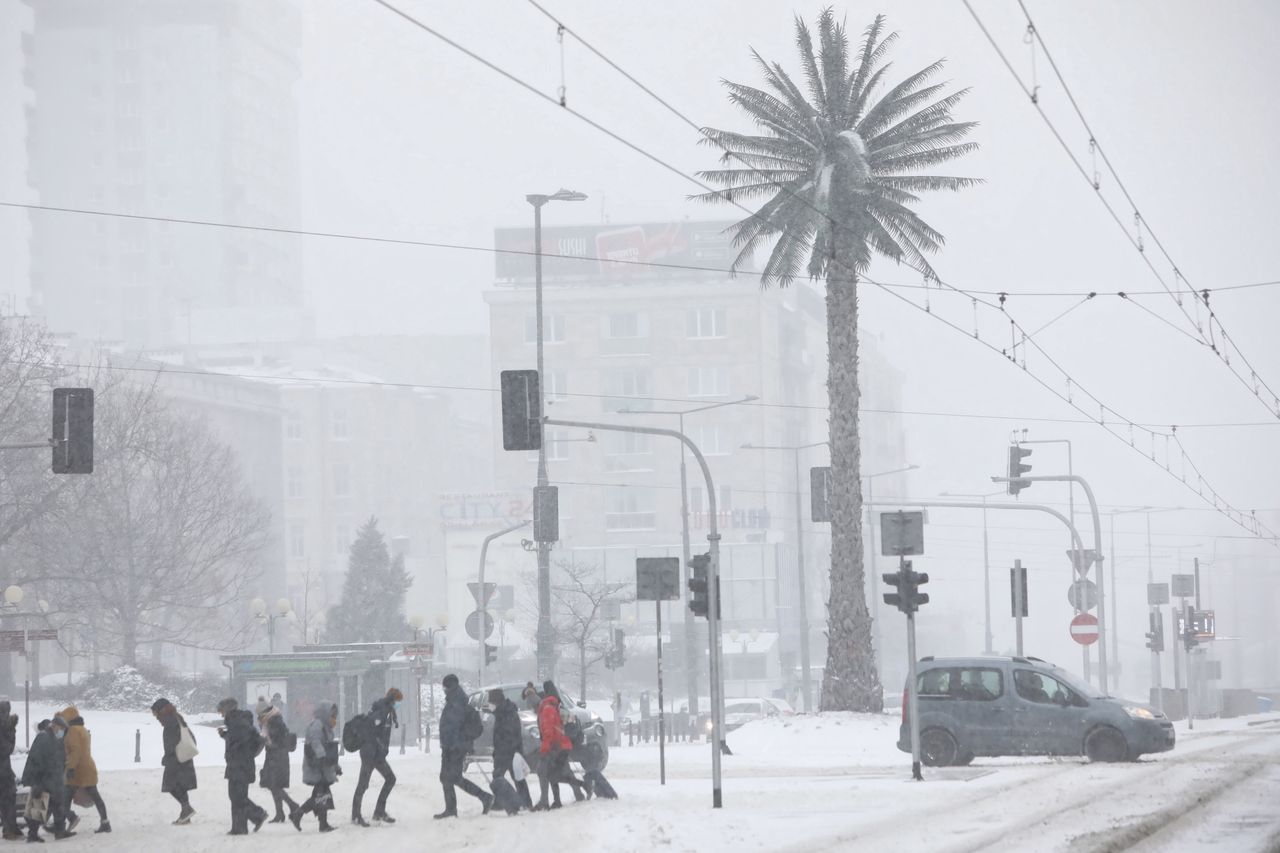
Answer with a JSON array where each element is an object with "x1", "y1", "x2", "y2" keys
[{"x1": 22, "y1": 0, "x2": 312, "y2": 347}]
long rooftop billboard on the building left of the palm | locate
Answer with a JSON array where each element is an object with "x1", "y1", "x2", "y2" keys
[{"x1": 494, "y1": 220, "x2": 754, "y2": 284}]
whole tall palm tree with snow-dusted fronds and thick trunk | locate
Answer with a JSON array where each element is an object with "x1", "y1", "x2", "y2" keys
[{"x1": 696, "y1": 9, "x2": 978, "y2": 711}]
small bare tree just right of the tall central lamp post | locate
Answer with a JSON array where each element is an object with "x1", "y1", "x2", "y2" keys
[{"x1": 524, "y1": 560, "x2": 635, "y2": 699}]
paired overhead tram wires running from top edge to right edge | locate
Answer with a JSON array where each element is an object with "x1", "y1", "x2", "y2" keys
[{"x1": 964, "y1": 0, "x2": 1280, "y2": 419}]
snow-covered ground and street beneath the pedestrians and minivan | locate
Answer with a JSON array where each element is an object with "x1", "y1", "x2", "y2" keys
[{"x1": 14, "y1": 707, "x2": 1280, "y2": 853}]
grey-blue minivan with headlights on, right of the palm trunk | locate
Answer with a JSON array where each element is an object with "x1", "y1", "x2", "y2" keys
[{"x1": 897, "y1": 657, "x2": 1175, "y2": 766}]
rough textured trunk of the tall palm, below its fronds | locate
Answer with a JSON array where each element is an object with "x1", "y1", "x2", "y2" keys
[{"x1": 819, "y1": 229, "x2": 884, "y2": 712}]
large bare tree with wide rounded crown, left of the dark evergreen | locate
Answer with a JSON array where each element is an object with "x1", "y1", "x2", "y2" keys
[{"x1": 20, "y1": 371, "x2": 269, "y2": 665}]
